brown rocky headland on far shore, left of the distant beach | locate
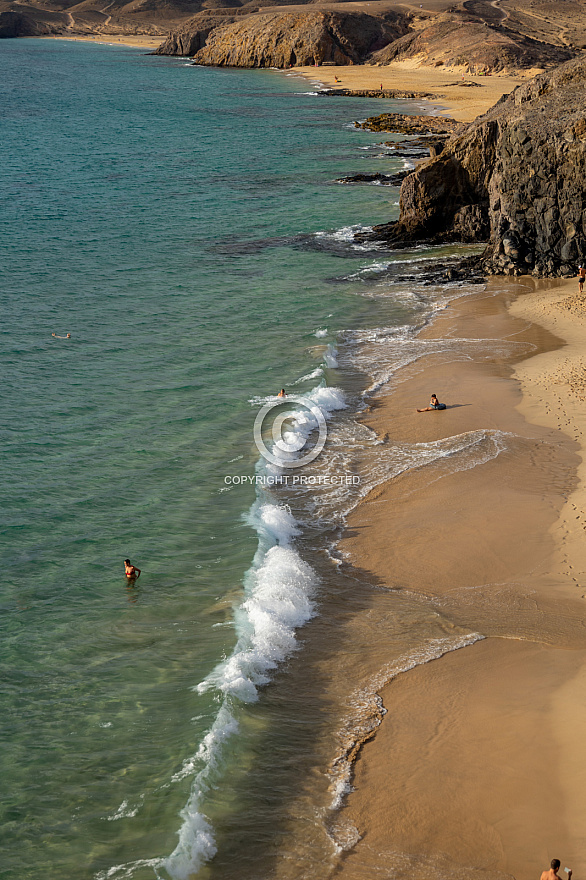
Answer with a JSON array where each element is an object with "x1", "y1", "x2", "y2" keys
[{"x1": 157, "y1": 10, "x2": 407, "y2": 68}]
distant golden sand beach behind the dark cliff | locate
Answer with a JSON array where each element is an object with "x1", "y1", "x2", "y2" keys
[{"x1": 295, "y1": 61, "x2": 537, "y2": 122}]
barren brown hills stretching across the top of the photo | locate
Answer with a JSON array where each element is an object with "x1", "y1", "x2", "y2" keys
[{"x1": 0, "y1": 0, "x2": 586, "y2": 73}]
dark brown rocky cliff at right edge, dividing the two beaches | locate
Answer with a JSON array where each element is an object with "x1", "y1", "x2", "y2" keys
[{"x1": 373, "y1": 55, "x2": 586, "y2": 275}]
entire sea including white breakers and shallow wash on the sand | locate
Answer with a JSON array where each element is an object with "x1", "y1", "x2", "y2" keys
[{"x1": 0, "y1": 40, "x2": 504, "y2": 880}]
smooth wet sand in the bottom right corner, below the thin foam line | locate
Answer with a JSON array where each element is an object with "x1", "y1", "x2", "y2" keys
[{"x1": 336, "y1": 639, "x2": 586, "y2": 880}]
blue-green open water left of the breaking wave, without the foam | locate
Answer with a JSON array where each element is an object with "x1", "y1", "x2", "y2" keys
[{"x1": 0, "y1": 40, "x2": 434, "y2": 880}]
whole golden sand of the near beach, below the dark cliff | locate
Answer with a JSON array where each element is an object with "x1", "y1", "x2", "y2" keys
[{"x1": 335, "y1": 279, "x2": 586, "y2": 880}]
